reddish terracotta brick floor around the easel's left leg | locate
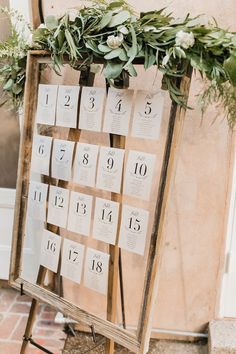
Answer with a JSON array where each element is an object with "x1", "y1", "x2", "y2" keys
[{"x1": 0, "y1": 287, "x2": 66, "y2": 354}]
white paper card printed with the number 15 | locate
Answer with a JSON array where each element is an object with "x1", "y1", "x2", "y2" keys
[{"x1": 119, "y1": 205, "x2": 149, "y2": 255}]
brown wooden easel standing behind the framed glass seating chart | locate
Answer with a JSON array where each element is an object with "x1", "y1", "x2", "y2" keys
[{"x1": 20, "y1": 60, "x2": 132, "y2": 354}]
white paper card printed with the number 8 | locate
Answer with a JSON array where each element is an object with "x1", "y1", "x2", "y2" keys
[{"x1": 73, "y1": 143, "x2": 99, "y2": 187}]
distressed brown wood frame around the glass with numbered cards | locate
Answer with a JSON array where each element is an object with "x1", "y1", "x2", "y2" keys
[{"x1": 10, "y1": 51, "x2": 191, "y2": 354}]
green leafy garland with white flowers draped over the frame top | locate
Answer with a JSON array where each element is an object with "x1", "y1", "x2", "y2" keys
[{"x1": 0, "y1": 0, "x2": 236, "y2": 126}]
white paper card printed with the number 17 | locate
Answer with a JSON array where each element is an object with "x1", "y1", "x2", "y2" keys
[{"x1": 61, "y1": 238, "x2": 85, "y2": 284}]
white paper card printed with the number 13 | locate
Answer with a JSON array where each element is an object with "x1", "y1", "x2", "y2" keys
[{"x1": 67, "y1": 192, "x2": 93, "y2": 236}]
